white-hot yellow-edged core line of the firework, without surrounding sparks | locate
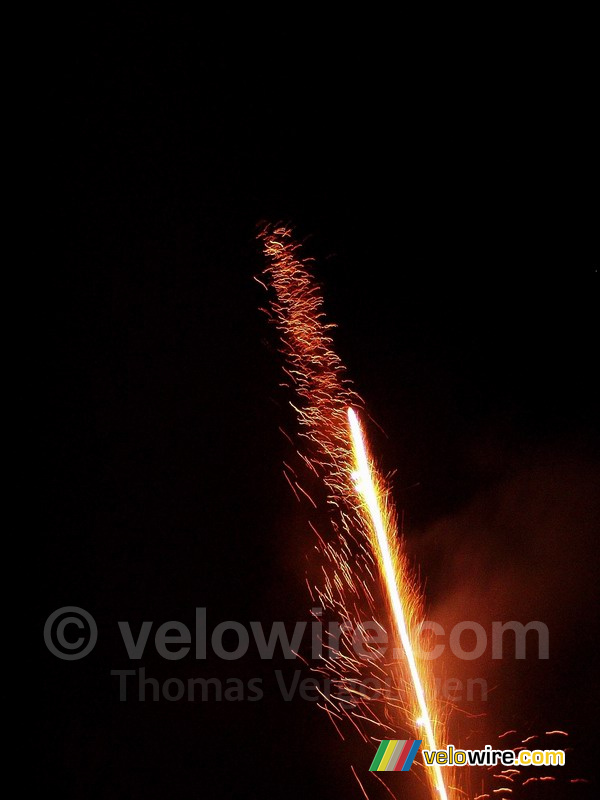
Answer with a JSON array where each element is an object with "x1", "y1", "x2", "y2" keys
[{"x1": 348, "y1": 408, "x2": 448, "y2": 800}]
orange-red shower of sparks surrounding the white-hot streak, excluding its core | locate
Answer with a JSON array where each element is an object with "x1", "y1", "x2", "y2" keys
[{"x1": 257, "y1": 226, "x2": 464, "y2": 800}]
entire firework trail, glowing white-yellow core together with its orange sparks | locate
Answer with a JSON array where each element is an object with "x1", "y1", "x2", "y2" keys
[{"x1": 259, "y1": 226, "x2": 455, "y2": 800}]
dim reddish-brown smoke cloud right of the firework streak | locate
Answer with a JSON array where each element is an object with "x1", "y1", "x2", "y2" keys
[{"x1": 410, "y1": 448, "x2": 600, "y2": 743}]
